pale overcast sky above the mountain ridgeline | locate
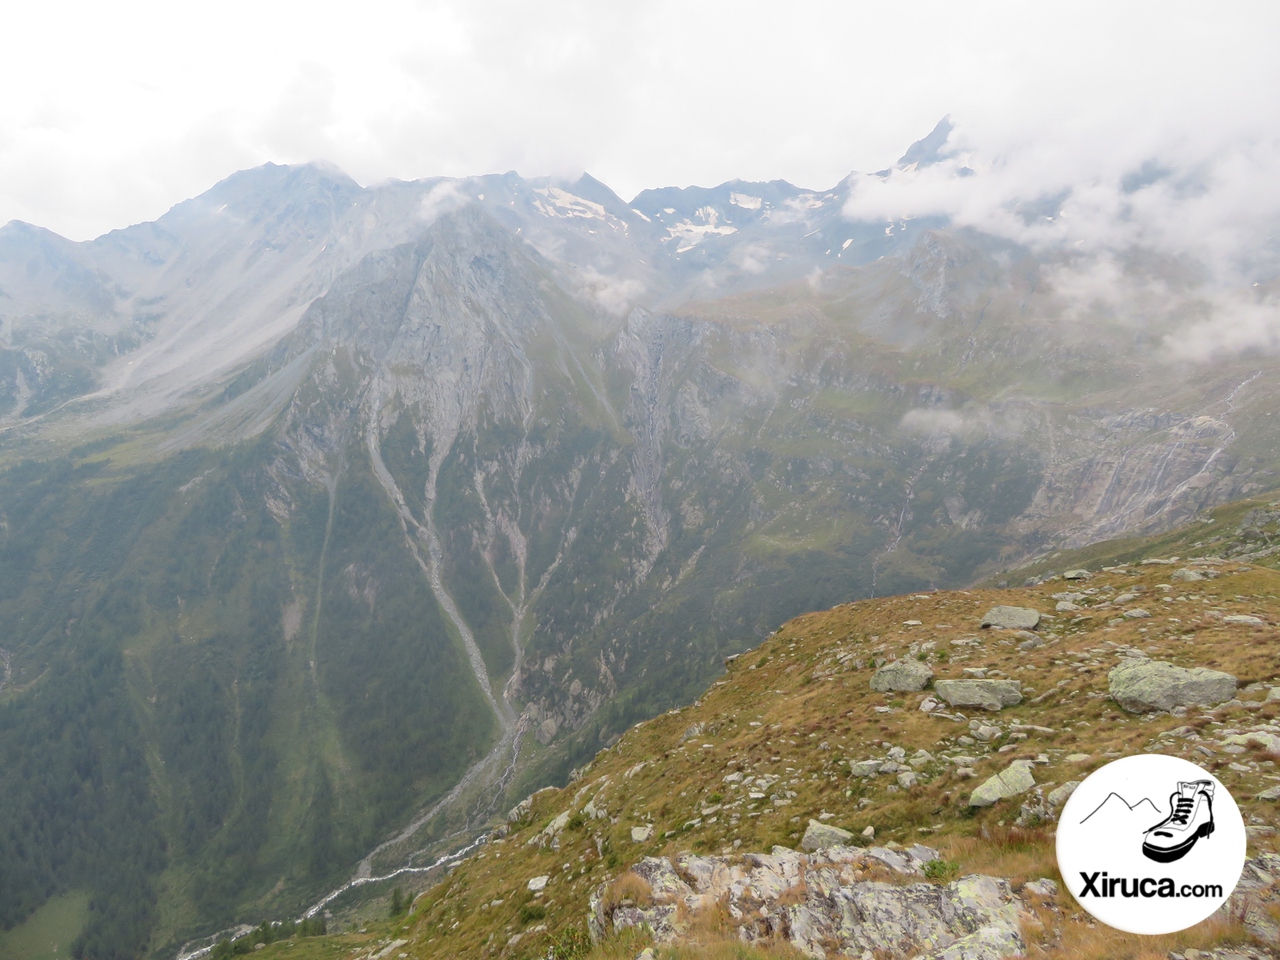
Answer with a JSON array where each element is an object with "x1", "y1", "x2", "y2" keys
[{"x1": 0, "y1": 0, "x2": 1280, "y2": 252}]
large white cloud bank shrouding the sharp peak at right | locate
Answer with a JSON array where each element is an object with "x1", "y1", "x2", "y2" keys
[{"x1": 845, "y1": 123, "x2": 1280, "y2": 360}]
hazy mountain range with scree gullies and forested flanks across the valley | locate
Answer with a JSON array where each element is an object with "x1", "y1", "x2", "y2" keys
[{"x1": 0, "y1": 123, "x2": 1280, "y2": 957}]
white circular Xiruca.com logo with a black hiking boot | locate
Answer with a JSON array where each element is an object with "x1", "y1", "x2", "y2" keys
[{"x1": 1057, "y1": 754, "x2": 1245, "y2": 933}]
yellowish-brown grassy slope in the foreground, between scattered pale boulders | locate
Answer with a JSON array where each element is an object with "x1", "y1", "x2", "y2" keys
[{"x1": 254, "y1": 506, "x2": 1280, "y2": 960}]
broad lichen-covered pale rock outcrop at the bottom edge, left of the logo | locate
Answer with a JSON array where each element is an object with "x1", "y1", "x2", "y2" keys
[{"x1": 588, "y1": 846, "x2": 1024, "y2": 960}]
